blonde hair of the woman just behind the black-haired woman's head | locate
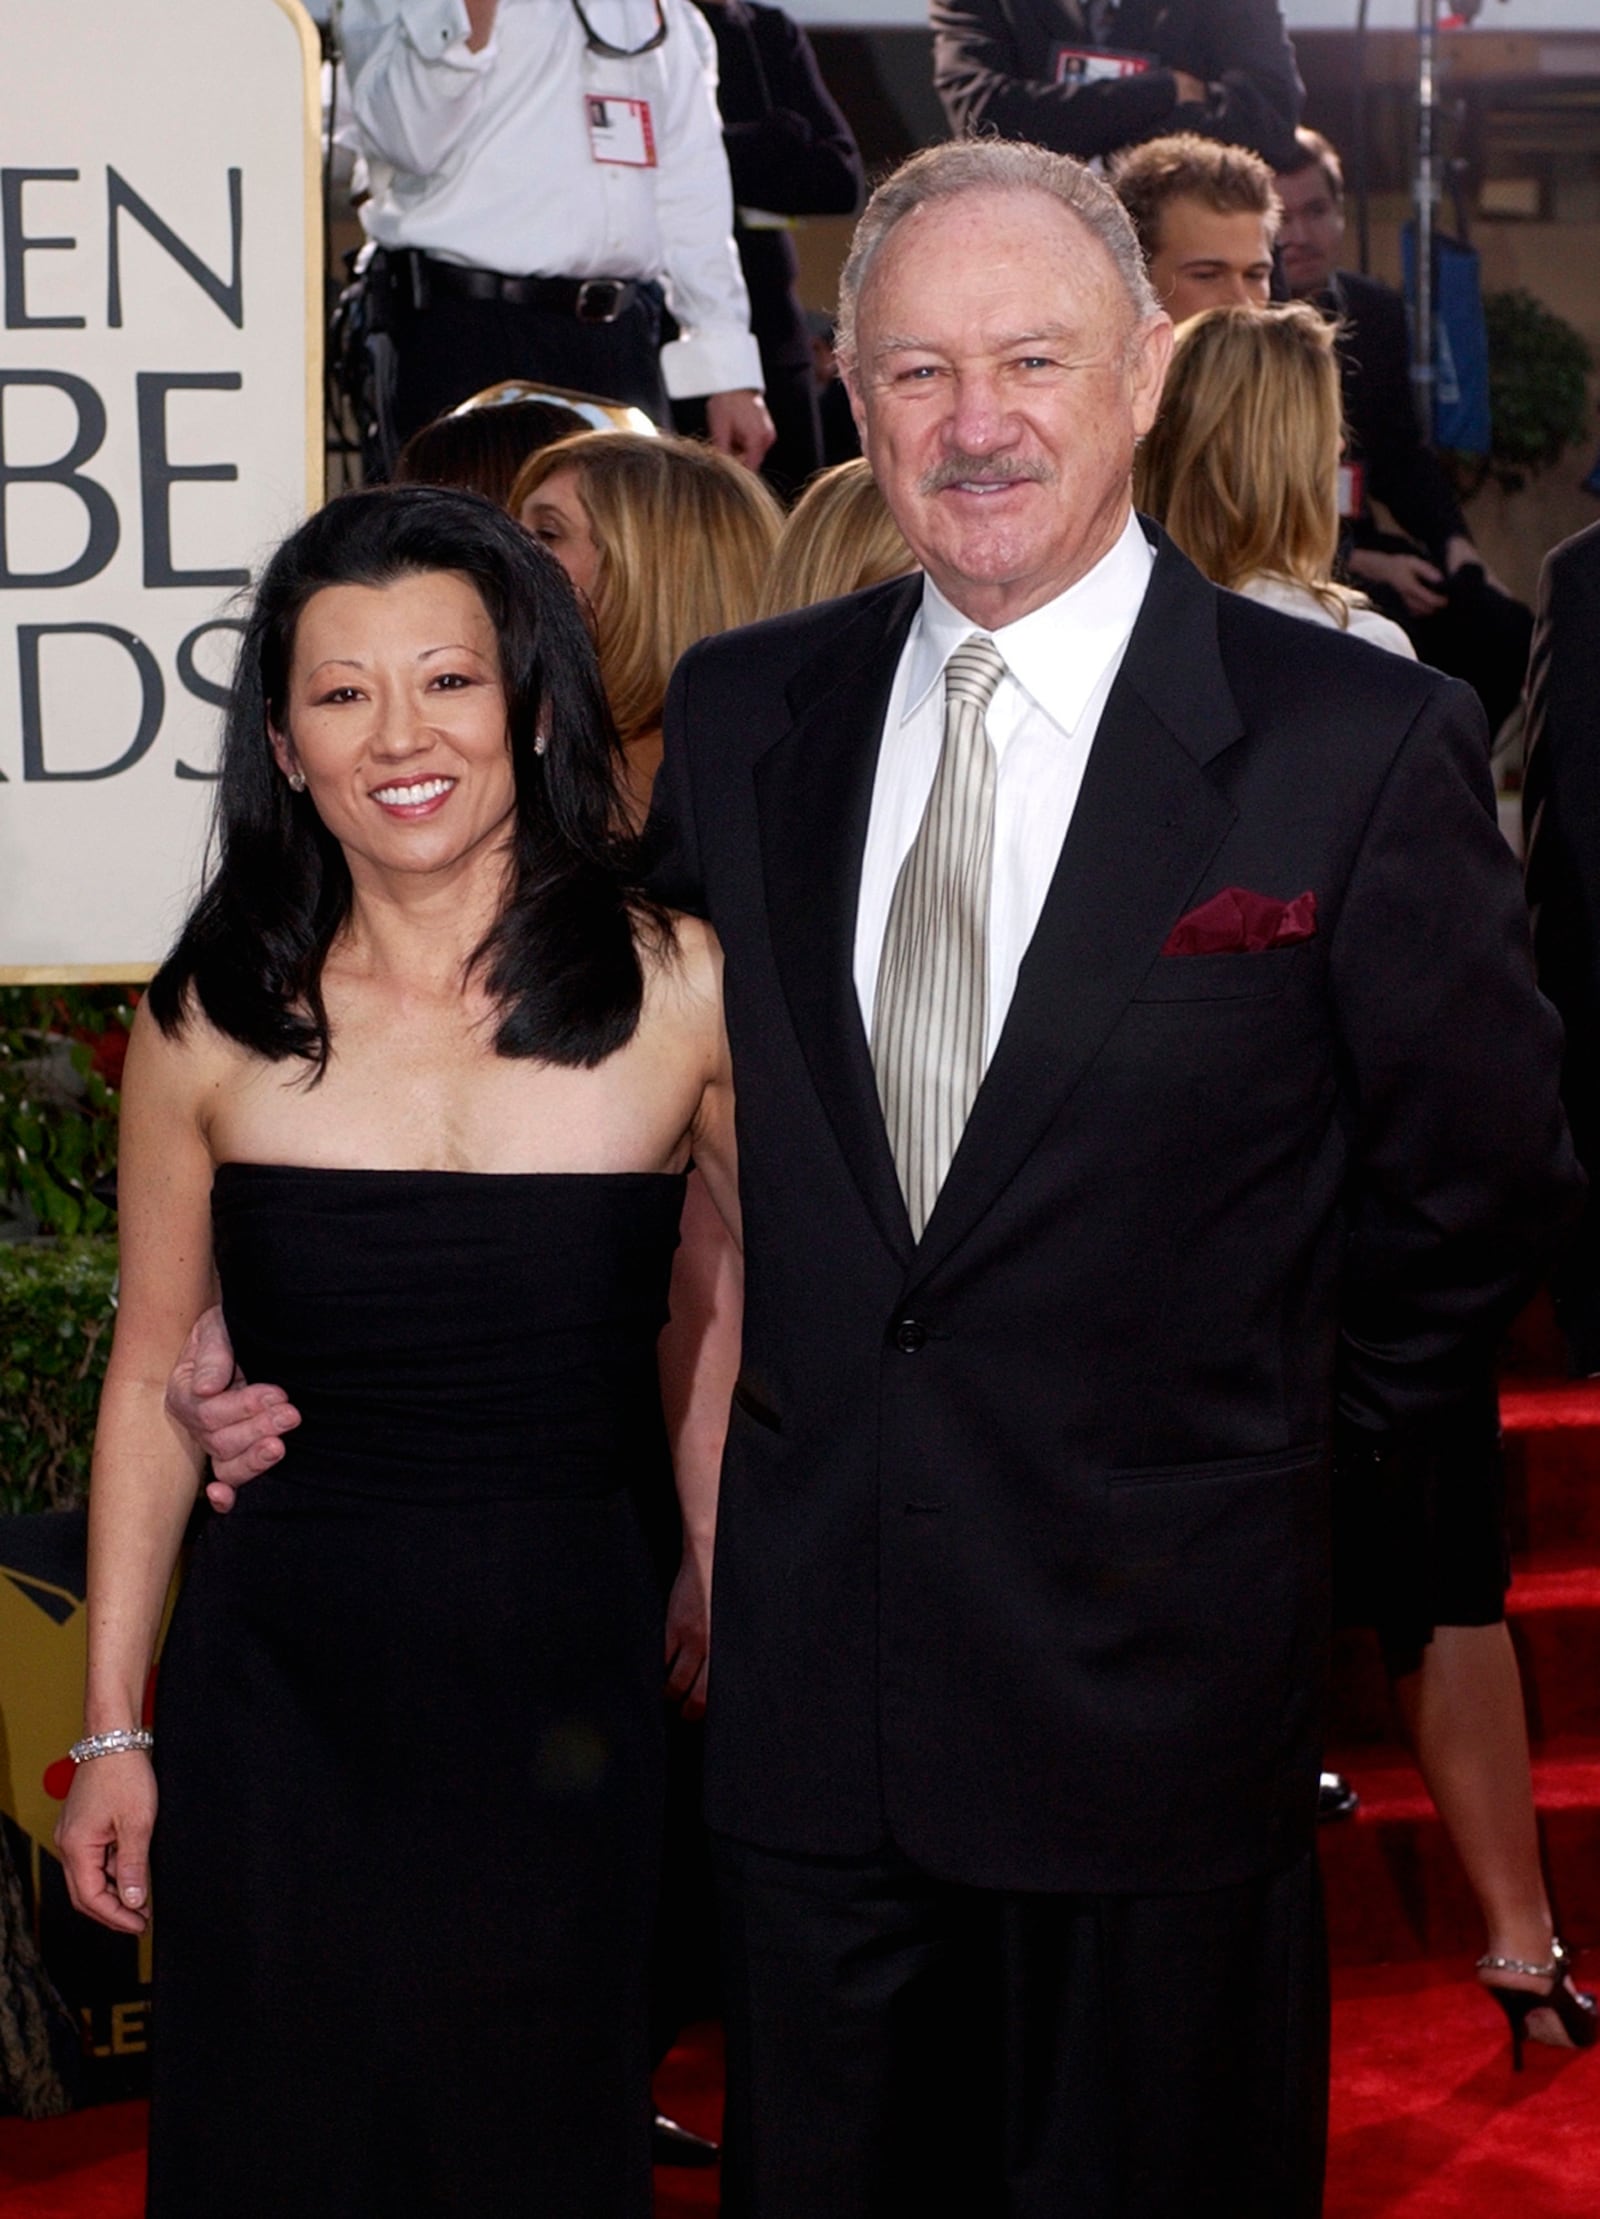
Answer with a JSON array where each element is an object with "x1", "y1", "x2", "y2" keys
[{"x1": 508, "y1": 430, "x2": 783, "y2": 746}]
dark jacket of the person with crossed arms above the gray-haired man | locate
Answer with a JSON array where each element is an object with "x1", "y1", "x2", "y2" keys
[{"x1": 930, "y1": 0, "x2": 1303, "y2": 169}]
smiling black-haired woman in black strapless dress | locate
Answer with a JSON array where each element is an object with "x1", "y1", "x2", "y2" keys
[{"x1": 62, "y1": 488, "x2": 732, "y2": 2219}]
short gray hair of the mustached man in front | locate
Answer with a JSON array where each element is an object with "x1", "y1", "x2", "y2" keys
[{"x1": 834, "y1": 138, "x2": 1161, "y2": 368}]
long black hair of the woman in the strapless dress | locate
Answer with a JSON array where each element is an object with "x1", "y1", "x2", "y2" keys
[{"x1": 149, "y1": 486, "x2": 668, "y2": 1076}]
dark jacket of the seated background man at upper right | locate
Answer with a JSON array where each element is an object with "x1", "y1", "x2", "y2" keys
[{"x1": 1329, "y1": 271, "x2": 1467, "y2": 564}]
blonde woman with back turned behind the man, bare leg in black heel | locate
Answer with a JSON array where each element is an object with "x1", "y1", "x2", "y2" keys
[{"x1": 1134, "y1": 302, "x2": 1596, "y2": 2066}]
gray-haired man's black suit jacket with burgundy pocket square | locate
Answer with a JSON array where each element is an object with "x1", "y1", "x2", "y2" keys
[{"x1": 661, "y1": 544, "x2": 1576, "y2": 1893}]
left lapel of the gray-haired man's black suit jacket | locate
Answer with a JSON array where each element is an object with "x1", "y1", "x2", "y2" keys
[{"x1": 755, "y1": 575, "x2": 921, "y2": 1263}]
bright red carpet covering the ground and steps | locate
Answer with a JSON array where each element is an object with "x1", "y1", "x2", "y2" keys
[{"x1": 0, "y1": 1371, "x2": 1600, "y2": 2219}]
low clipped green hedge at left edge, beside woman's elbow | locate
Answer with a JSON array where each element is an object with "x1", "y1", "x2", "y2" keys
[{"x1": 0, "y1": 1234, "x2": 118, "y2": 1516}]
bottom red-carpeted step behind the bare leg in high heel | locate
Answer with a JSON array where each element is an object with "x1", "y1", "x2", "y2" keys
[{"x1": 1318, "y1": 1737, "x2": 1600, "y2": 1964}]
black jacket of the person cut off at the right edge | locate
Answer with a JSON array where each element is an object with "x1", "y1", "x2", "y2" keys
[{"x1": 1522, "y1": 524, "x2": 1600, "y2": 1371}]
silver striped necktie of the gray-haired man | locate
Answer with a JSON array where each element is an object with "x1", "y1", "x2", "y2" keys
[{"x1": 872, "y1": 632, "x2": 1005, "y2": 1240}]
